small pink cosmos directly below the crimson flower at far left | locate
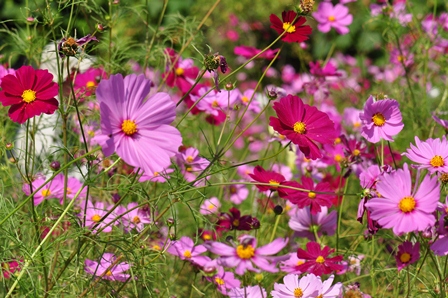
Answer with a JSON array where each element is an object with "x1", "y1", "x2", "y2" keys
[{"x1": 22, "y1": 173, "x2": 64, "y2": 206}]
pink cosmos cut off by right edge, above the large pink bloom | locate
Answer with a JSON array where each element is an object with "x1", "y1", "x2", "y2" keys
[{"x1": 403, "y1": 136, "x2": 448, "y2": 174}]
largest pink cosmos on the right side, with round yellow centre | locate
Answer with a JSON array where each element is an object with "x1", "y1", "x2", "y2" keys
[{"x1": 365, "y1": 164, "x2": 440, "y2": 235}]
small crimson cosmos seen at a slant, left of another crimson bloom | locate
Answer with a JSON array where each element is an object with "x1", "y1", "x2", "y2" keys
[{"x1": 249, "y1": 166, "x2": 299, "y2": 198}]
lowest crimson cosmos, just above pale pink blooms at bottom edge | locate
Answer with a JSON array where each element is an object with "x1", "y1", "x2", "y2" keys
[{"x1": 297, "y1": 242, "x2": 344, "y2": 276}]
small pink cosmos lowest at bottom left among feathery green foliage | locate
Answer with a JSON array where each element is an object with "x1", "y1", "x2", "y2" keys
[{"x1": 84, "y1": 253, "x2": 131, "y2": 282}]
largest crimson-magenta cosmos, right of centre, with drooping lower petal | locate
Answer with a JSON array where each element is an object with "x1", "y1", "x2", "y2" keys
[{"x1": 269, "y1": 94, "x2": 338, "y2": 159}]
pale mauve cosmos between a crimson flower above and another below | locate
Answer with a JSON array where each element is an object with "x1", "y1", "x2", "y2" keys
[{"x1": 288, "y1": 206, "x2": 337, "y2": 241}]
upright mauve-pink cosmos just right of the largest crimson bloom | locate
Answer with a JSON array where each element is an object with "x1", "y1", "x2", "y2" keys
[{"x1": 359, "y1": 96, "x2": 404, "y2": 143}]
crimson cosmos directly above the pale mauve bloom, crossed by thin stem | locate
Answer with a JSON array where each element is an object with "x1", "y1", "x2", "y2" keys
[{"x1": 286, "y1": 177, "x2": 333, "y2": 214}]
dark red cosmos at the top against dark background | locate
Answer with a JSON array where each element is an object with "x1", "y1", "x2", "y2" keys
[{"x1": 269, "y1": 10, "x2": 312, "y2": 42}]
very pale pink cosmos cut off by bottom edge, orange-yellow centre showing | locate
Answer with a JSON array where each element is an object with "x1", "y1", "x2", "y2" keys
[{"x1": 271, "y1": 274, "x2": 322, "y2": 298}]
